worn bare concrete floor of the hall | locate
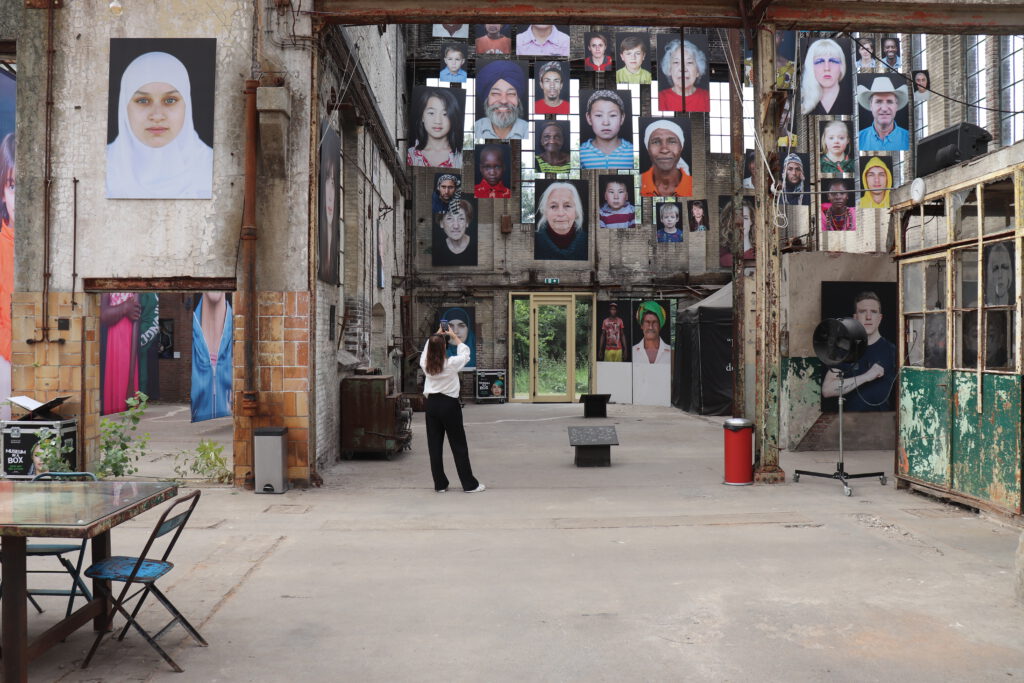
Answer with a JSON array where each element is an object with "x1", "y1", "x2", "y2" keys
[{"x1": 19, "y1": 404, "x2": 1024, "y2": 682}]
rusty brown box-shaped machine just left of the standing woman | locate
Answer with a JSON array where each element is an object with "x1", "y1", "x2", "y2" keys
[{"x1": 340, "y1": 371, "x2": 413, "y2": 460}]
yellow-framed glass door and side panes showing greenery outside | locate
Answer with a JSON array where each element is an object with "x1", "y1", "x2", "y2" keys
[{"x1": 508, "y1": 293, "x2": 594, "y2": 402}]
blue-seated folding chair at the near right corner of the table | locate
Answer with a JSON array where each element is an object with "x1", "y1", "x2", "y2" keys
[{"x1": 82, "y1": 489, "x2": 207, "y2": 674}]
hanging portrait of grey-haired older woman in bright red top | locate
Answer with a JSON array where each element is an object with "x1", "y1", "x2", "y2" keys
[{"x1": 657, "y1": 34, "x2": 711, "y2": 112}]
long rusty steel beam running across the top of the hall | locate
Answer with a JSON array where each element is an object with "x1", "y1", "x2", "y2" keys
[{"x1": 311, "y1": 0, "x2": 1024, "y2": 34}]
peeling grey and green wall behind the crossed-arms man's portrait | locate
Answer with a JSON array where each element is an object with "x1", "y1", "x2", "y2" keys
[{"x1": 779, "y1": 252, "x2": 897, "y2": 450}]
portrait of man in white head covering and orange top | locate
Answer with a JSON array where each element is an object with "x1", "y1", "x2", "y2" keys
[{"x1": 640, "y1": 117, "x2": 693, "y2": 197}]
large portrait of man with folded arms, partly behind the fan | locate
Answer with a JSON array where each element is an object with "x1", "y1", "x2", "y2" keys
[{"x1": 821, "y1": 282, "x2": 897, "y2": 413}]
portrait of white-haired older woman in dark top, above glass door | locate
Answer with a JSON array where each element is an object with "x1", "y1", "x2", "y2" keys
[{"x1": 534, "y1": 180, "x2": 589, "y2": 261}]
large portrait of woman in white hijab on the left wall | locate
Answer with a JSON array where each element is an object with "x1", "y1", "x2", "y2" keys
[{"x1": 106, "y1": 39, "x2": 216, "y2": 199}]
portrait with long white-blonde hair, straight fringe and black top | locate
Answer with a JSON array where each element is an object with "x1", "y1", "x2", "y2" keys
[{"x1": 800, "y1": 38, "x2": 854, "y2": 116}]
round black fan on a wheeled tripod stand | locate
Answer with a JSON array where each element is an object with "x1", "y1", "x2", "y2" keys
[{"x1": 793, "y1": 317, "x2": 886, "y2": 496}]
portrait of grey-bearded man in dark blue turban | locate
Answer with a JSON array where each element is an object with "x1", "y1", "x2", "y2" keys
[{"x1": 473, "y1": 59, "x2": 529, "y2": 140}]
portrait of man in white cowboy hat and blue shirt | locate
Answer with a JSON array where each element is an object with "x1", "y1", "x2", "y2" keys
[{"x1": 857, "y1": 74, "x2": 910, "y2": 152}]
